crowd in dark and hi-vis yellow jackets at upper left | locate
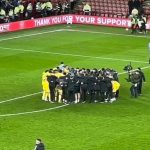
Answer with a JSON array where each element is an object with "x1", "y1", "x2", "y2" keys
[{"x1": 0, "y1": 0, "x2": 76, "y2": 23}]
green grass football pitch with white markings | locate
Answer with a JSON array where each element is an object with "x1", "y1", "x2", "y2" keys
[{"x1": 0, "y1": 25, "x2": 150, "y2": 150}]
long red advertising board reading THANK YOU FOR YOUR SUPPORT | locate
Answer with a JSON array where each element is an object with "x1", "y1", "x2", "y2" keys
[{"x1": 0, "y1": 15, "x2": 150, "y2": 33}]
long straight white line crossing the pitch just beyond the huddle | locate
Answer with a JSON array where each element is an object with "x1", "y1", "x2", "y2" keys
[{"x1": 0, "y1": 47, "x2": 148, "y2": 64}]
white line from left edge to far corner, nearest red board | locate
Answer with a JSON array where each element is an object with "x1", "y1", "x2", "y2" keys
[{"x1": 0, "y1": 29, "x2": 63, "y2": 42}]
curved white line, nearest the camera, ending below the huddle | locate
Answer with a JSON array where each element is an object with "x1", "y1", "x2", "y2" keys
[{"x1": 0, "y1": 104, "x2": 69, "y2": 118}]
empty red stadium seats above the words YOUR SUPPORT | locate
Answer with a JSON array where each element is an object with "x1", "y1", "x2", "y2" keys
[{"x1": 75, "y1": 0, "x2": 150, "y2": 18}]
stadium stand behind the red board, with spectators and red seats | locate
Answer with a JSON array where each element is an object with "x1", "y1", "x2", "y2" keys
[{"x1": 0, "y1": 0, "x2": 150, "y2": 23}]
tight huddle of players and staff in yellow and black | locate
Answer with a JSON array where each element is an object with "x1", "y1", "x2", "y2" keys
[{"x1": 42, "y1": 62, "x2": 120, "y2": 103}]
